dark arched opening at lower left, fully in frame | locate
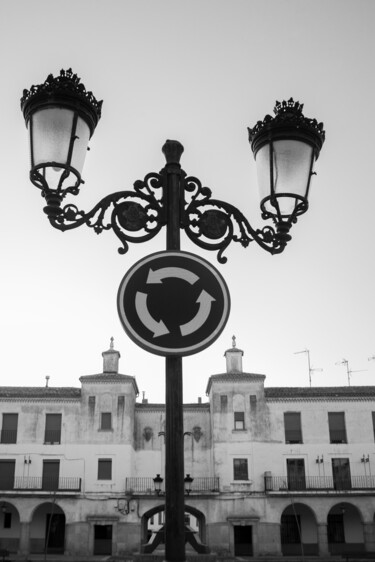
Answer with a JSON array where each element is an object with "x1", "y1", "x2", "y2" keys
[{"x1": 30, "y1": 503, "x2": 65, "y2": 554}]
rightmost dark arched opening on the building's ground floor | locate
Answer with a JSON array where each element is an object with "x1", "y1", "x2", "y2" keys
[{"x1": 327, "y1": 502, "x2": 365, "y2": 554}]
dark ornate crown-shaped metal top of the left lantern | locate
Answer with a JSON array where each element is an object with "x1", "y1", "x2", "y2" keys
[{"x1": 21, "y1": 68, "x2": 103, "y2": 136}]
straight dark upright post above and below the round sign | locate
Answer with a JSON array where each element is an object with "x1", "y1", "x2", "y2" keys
[{"x1": 163, "y1": 141, "x2": 185, "y2": 562}]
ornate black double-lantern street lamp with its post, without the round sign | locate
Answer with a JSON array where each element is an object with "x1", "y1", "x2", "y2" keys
[{"x1": 21, "y1": 69, "x2": 325, "y2": 561}]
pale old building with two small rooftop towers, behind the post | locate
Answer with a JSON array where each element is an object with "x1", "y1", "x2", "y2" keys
[{"x1": 0, "y1": 336, "x2": 375, "y2": 556}]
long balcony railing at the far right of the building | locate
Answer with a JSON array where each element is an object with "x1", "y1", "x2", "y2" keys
[{"x1": 264, "y1": 475, "x2": 375, "y2": 492}]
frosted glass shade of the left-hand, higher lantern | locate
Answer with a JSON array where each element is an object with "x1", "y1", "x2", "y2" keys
[{"x1": 29, "y1": 107, "x2": 90, "y2": 189}]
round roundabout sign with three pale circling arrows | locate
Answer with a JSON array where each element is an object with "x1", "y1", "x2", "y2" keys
[{"x1": 117, "y1": 251, "x2": 230, "y2": 356}]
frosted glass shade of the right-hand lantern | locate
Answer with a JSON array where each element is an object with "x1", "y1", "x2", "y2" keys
[{"x1": 256, "y1": 139, "x2": 315, "y2": 219}]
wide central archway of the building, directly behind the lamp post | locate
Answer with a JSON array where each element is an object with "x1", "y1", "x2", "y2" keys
[{"x1": 141, "y1": 505, "x2": 209, "y2": 554}]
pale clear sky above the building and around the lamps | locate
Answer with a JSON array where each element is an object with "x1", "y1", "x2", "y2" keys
[{"x1": 0, "y1": 0, "x2": 375, "y2": 402}]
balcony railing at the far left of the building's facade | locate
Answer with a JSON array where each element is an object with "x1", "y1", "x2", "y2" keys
[{"x1": 0, "y1": 476, "x2": 81, "y2": 492}]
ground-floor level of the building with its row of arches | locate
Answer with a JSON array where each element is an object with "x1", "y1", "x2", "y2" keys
[{"x1": 0, "y1": 494, "x2": 375, "y2": 557}]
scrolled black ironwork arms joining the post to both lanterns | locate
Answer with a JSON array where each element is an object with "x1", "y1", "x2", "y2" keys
[{"x1": 43, "y1": 150, "x2": 290, "y2": 264}]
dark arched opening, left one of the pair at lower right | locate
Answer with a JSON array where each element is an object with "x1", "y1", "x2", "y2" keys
[{"x1": 280, "y1": 503, "x2": 319, "y2": 556}]
